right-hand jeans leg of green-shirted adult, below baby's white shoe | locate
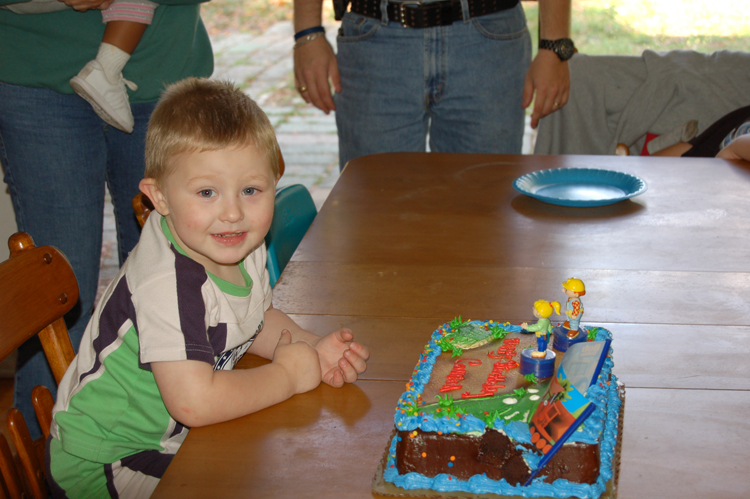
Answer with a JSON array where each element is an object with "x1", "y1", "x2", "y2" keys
[{"x1": 105, "y1": 102, "x2": 156, "y2": 265}]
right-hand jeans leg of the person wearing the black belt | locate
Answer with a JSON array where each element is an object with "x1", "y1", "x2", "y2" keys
[{"x1": 429, "y1": 4, "x2": 531, "y2": 154}]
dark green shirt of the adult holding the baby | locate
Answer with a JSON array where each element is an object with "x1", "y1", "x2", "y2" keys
[{"x1": 0, "y1": 0, "x2": 213, "y2": 104}]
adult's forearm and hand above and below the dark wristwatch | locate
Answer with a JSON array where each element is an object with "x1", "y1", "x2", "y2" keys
[{"x1": 523, "y1": 0, "x2": 571, "y2": 128}]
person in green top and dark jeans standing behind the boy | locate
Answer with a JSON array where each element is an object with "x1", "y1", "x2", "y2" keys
[{"x1": 0, "y1": 0, "x2": 213, "y2": 438}]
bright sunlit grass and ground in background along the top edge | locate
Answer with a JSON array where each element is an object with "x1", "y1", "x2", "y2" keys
[{"x1": 201, "y1": 0, "x2": 750, "y2": 55}]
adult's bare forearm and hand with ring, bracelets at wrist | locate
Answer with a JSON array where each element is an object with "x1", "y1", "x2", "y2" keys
[{"x1": 294, "y1": 0, "x2": 341, "y2": 114}]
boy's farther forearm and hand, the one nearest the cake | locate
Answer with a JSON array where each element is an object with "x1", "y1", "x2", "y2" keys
[{"x1": 256, "y1": 307, "x2": 370, "y2": 387}]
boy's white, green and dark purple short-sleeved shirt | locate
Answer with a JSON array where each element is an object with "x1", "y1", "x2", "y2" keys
[{"x1": 51, "y1": 213, "x2": 272, "y2": 477}]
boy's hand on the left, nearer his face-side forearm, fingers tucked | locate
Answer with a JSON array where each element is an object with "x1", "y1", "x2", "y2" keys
[{"x1": 273, "y1": 329, "x2": 321, "y2": 394}]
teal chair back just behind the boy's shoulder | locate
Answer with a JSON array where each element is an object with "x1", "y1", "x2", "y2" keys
[{"x1": 266, "y1": 184, "x2": 318, "y2": 287}]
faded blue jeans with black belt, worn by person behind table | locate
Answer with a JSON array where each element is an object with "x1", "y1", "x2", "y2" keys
[{"x1": 334, "y1": 3, "x2": 531, "y2": 168}]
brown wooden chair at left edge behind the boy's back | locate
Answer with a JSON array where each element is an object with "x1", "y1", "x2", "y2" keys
[{"x1": 0, "y1": 232, "x2": 78, "y2": 498}]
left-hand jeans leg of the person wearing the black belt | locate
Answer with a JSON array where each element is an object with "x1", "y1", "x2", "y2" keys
[{"x1": 334, "y1": 13, "x2": 428, "y2": 169}]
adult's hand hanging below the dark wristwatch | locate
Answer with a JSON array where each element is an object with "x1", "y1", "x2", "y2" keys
[{"x1": 522, "y1": 49, "x2": 570, "y2": 128}]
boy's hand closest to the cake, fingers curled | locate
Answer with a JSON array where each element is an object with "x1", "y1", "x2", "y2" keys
[{"x1": 313, "y1": 329, "x2": 370, "y2": 388}]
